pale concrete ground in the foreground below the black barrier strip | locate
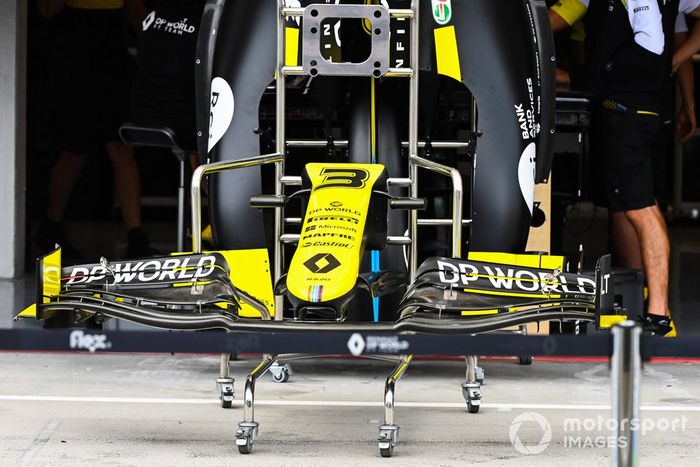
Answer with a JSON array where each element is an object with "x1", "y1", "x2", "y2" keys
[{"x1": 0, "y1": 352, "x2": 700, "y2": 466}]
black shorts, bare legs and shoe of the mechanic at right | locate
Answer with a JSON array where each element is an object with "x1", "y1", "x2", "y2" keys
[{"x1": 591, "y1": 107, "x2": 673, "y2": 335}]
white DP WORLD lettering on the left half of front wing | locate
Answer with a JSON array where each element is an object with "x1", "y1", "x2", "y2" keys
[{"x1": 62, "y1": 256, "x2": 216, "y2": 286}]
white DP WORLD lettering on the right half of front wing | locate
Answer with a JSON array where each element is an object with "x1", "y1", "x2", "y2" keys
[{"x1": 437, "y1": 260, "x2": 595, "y2": 295}]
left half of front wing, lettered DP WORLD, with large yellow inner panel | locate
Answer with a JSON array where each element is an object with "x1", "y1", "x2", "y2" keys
[{"x1": 19, "y1": 248, "x2": 274, "y2": 328}]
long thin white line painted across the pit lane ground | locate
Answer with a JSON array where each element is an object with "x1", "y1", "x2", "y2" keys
[{"x1": 0, "y1": 395, "x2": 700, "y2": 412}]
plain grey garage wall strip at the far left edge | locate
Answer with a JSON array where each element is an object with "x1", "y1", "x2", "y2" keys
[{"x1": 0, "y1": 0, "x2": 27, "y2": 278}]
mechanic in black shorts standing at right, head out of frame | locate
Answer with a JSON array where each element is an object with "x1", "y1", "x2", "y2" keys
[{"x1": 550, "y1": 0, "x2": 700, "y2": 335}]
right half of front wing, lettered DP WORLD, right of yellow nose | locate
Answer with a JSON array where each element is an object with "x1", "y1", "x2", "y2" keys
[{"x1": 399, "y1": 253, "x2": 624, "y2": 328}]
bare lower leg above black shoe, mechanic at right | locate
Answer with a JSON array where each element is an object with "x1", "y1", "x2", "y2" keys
[{"x1": 625, "y1": 205, "x2": 671, "y2": 316}]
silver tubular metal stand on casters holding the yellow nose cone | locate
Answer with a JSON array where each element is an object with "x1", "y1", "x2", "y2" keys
[{"x1": 191, "y1": 0, "x2": 481, "y2": 456}]
